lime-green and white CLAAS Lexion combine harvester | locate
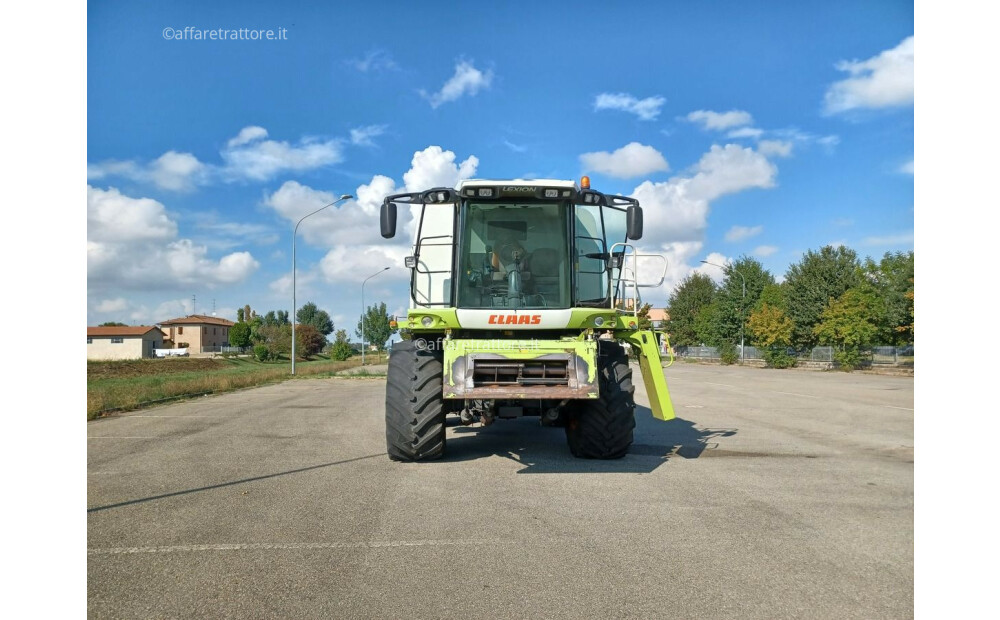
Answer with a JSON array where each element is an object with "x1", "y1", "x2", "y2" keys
[{"x1": 381, "y1": 177, "x2": 674, "y2": 461}]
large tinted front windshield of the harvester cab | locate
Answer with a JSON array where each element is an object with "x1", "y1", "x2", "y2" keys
[{"x1": 458, "y1": 202, "x2": 570, "y2": 309}]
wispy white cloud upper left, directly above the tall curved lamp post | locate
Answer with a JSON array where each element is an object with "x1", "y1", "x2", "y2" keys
[{"x1": 221, "y1": 127, "x2": 343, "y2": 181}]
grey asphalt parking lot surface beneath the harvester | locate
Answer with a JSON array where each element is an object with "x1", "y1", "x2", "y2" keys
[{"x1": 87, "y1": 364, "x2": 913, "y2": 619}]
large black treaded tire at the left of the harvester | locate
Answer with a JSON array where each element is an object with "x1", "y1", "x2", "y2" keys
[{"x1": 385, "y1": 340, "x2": 445, "y2": 461}]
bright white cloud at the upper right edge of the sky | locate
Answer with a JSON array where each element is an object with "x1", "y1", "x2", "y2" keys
[{"x1": 824, "y1": 36, "x2": 914, "y2": 114}]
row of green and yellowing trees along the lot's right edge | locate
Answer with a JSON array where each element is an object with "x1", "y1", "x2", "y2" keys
[{"x1": 666, "y1": 246, "x2": 914, "y2": 367}]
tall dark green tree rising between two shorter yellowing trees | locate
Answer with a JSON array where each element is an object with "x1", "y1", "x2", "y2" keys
[{"x1": 784, "y1": 245, "x2": 861, "y2": 347}]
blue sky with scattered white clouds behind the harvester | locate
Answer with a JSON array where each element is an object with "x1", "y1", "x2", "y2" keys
[{"x1": 87, "y1": 1, "x2": 914, "y2": 332}]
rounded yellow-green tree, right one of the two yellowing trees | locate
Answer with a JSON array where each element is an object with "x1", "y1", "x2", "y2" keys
[{"x1": 813, "y1": 288, "x2": 883, "y2": 370}]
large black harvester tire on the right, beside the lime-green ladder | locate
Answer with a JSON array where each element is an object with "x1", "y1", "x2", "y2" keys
[{"x1": 566, "y1": 340, "x2": 635, "y2": 459}]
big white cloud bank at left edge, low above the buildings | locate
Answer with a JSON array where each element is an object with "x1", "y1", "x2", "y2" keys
[{"x1": 87, "y1": 185, "x2": 259, "y2": 294}]
